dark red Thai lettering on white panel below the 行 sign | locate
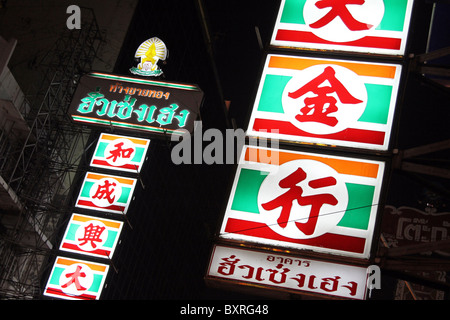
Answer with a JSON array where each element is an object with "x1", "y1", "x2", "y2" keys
[{"x1": 217, "y1": 255, "x2": 358, "y2": 296}]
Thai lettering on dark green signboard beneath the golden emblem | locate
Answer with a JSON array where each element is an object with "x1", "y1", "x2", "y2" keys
[{"x1": 77, "y1": 90, "x2": 190, "y2": 128}]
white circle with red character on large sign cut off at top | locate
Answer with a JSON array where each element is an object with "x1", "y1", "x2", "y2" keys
[{"x1": 303, "y1": 0, "x2": 384, "y2": 42}]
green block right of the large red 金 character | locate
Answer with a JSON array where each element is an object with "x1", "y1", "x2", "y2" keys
[{"x1": 358, "y1": 83, "x2": 392, "y2": 124}]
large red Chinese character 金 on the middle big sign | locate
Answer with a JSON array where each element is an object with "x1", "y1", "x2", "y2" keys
[{"x1": 288, "y1": 66, "x2": 362, "y2": 127}]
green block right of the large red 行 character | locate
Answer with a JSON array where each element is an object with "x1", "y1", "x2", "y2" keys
[{"x1": 338, "y1": 182, "x2": 375, "y2": 230}]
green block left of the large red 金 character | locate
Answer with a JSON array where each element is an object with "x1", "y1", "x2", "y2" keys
[{"x1": 258, "y1": 74, "x2": 292, "y2": 113}]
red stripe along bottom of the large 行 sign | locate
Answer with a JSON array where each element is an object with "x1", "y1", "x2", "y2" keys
[{"x1": 225, "y1": 218, "x2": 366, "y2": 253}]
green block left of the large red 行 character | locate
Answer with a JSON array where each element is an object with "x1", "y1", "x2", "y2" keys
[{"x1": 231, "y1": 169, "x2": 269, "y2": 213}]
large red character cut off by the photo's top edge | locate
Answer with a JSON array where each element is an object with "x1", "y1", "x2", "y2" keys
[{"x1": 310, "y1": 0, "x2": 373, "y2": 31}]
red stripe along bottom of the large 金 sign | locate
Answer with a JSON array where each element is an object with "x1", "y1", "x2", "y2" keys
[{"x1": 253, "y1": 119, "x2": 385, "y2": 145}]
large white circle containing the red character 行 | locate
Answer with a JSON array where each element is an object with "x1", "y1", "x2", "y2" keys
[{"x1": 258, "y1": 159, "x2": 348, "y2": 239}]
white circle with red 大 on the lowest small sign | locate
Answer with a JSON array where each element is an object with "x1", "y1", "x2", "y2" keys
[{"x1": 59, "y1": 263, "x2": 94, "y2": 296}]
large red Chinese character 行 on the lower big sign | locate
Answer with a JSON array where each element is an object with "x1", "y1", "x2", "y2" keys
[{"x1": 262, "y1": 168, "x2": 338, "y2": 235}]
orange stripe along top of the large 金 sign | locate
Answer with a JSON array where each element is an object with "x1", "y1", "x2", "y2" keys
[{"x1": 269, "y1": 56, "x2": 396, "y2": 79}]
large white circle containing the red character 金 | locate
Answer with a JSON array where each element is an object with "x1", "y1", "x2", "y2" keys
[{"x1": 281, "y1": 64, "x2": 367, "y2": 134}]
